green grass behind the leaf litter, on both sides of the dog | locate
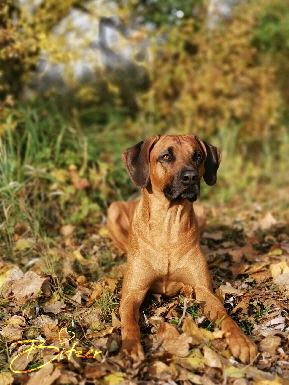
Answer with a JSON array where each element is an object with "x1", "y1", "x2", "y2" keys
[{"x1": 0, "y1": 101, "x2": 289, "y2": 250}]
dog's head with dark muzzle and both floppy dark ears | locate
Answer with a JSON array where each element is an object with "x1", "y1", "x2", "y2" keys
[{"x1": 122, "y1": 135, "x2": 221, "y2": 202}]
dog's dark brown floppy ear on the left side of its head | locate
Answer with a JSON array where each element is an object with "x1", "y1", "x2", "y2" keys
[{"x1": 122, "y1": 135, "x2": 160, "y2": 188}]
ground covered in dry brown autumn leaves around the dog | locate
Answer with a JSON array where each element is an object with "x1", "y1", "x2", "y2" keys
[{"x1": 0, "y1": 205, "x2": 289, "y2": 385}]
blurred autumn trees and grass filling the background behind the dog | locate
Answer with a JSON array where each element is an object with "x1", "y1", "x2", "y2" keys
[{"x1": 0, "y1": 0, "x2": 289, "y2": 239}]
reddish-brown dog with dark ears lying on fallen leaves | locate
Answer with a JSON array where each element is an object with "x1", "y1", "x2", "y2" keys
[{"x1": 108, "y1": 135, "x2": 257, "y2": 363}]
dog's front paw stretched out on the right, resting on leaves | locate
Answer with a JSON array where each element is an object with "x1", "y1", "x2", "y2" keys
[{"x1": 227, "y1": 330, "x2": 258, "y2": 364}]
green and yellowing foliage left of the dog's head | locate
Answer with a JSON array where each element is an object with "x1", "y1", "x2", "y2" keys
[{"x1": 0, "y1": 99, "x2": 128, "y2": 237}]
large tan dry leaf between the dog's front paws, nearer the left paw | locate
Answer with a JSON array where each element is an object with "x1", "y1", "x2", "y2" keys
[{"x1": 157, "y1": 322, "x2": 192, "y2": 357}]
